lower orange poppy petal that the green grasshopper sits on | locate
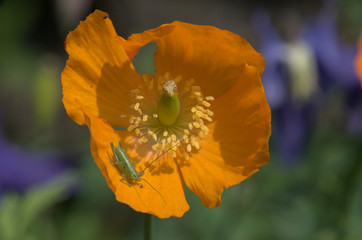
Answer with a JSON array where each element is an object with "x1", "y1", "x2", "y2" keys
[{"x1": 83, "y1": 104, "x2": 189, "y2": 218}]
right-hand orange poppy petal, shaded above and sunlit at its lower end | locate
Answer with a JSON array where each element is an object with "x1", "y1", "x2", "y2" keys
[{"x1": 181, "y1": 62, "x2": 271, "y2": 207}]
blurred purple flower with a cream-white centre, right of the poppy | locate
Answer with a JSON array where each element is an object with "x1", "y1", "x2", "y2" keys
[{"x1": 252, "y1": 7, "x2": 318, "y2": 165}]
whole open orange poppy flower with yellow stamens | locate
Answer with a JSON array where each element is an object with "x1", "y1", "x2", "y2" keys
[{"x1": 62, "y1": 10, "x2": 271, "y2": 218}]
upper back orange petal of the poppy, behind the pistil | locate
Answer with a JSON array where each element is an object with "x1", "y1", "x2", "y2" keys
[{"x1": 155, "y1": 21, "x2": 265, "y2": 97}]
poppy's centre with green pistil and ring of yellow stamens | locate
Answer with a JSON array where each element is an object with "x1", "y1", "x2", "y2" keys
[{"x1": 128, "y1": 73, "x2": 214, "y2": 159}]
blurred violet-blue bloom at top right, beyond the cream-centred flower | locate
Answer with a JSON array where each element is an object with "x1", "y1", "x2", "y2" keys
[{"x1": 304, "y1": 1, "x2": 359, "y2": 88}]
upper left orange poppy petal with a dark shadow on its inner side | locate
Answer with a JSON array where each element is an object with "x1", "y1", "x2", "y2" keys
[{"x1": 62, "y1": 10, "x2": 143, "y2": 126}]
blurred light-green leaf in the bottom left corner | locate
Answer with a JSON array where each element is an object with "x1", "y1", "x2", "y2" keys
[{"x1": 0, "y1": 181, "x2": 67, "y2": 240}]
